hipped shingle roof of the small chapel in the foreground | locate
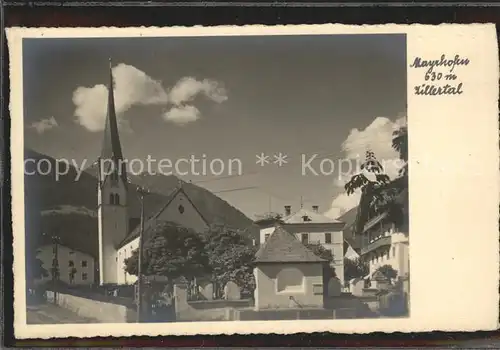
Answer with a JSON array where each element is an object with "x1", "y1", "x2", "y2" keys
[{"x1": 255, "y1": 226, "x2": 326, "y2": 263}]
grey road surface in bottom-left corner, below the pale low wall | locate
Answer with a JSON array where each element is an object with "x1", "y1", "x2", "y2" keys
[{"x1": 26, "y1": 304, "x2": 97, "y2": 324}]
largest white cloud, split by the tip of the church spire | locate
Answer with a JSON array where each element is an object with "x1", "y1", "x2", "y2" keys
[{"x1": 73, "y1": 63, "x2": 168, "y2": 131}]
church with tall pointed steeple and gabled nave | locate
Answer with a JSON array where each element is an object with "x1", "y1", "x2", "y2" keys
[{"x1": 97, "y1": 61, "x2": 209, "y2": 285}]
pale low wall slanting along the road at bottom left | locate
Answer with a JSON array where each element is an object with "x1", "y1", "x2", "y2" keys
[{"x1": 46, "y1": 291, "x2": 136, "y2": 323}]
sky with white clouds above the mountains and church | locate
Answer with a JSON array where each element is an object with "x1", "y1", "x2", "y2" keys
[{"x1": 23, "y1": 34, "x2": 407, "y2": 218}]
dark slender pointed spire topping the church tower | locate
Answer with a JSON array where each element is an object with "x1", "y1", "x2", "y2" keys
[{"x1": 101, "y1": 58, "x2": 127, "y2": 185}]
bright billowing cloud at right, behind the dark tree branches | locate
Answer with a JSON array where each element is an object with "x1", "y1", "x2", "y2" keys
[{"x1": 325, "y1": 117, "x2": 406, "y2": 218}]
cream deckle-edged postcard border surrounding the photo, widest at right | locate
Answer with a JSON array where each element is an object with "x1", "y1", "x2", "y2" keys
[{"x1": 7, "y1": 24, "x2": 500, "y2": 338}]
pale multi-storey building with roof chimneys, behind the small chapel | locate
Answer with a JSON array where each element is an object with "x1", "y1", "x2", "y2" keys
[{"x1": 257, "y1": 206, "x2": 344, "y2": 284}]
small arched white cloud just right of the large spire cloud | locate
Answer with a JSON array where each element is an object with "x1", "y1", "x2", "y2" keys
[{"x1": 170, "y1": 77, "x2": 227, "y2": 105}]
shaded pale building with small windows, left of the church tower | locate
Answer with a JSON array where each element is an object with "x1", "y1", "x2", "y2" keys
[{"x1": 35, "y1": 244, "x2": 95, "y2": 285}]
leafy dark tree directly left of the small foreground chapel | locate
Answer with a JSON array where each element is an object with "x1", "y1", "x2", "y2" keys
[{"x1": 205, "y1": 225, "x2": 256, "y2": 295}]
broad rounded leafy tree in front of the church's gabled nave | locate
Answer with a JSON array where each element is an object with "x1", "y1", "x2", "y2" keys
[{"x1": 125, "y1": 221, "x2": 212, "y2": 281}]
